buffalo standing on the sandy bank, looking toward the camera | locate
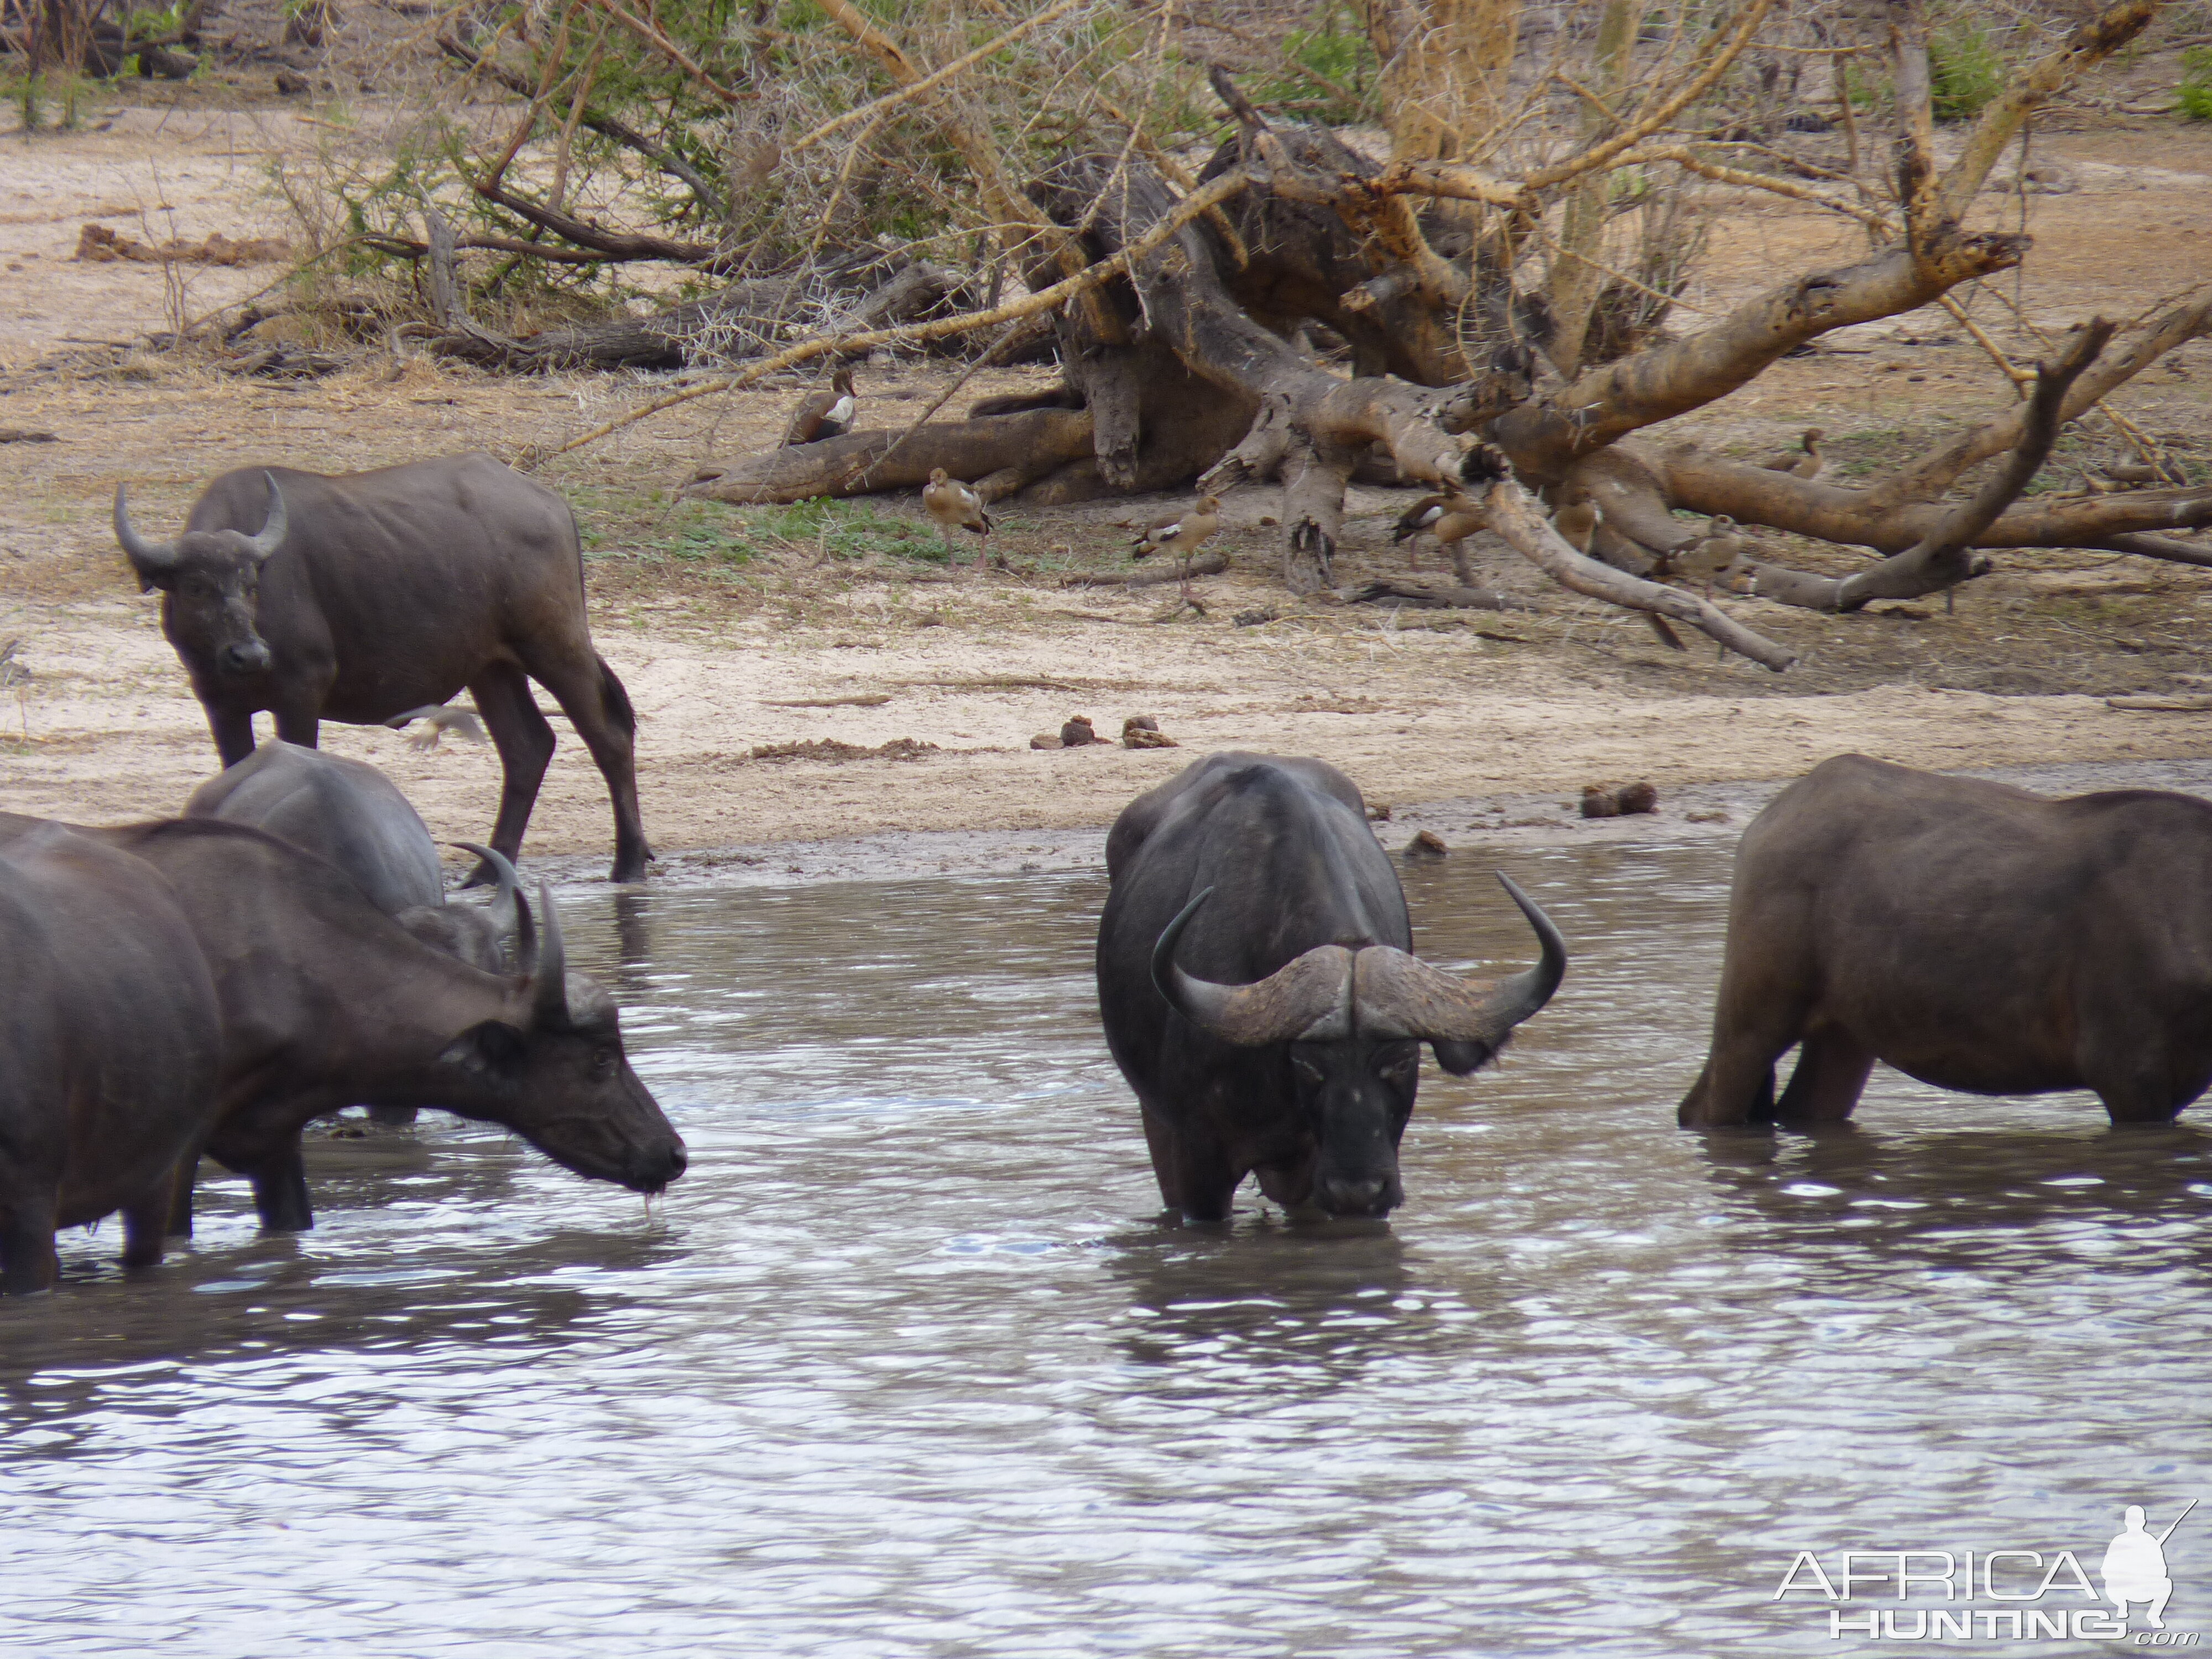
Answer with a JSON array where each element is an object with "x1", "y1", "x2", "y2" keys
[{"x1": 115, "y1": 456, "x2": 653, "y2": 880}]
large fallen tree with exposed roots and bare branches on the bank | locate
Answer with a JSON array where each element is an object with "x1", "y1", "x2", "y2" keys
[{"x1": 672, "y1": 0, "x2": 2212, "y2": 668}]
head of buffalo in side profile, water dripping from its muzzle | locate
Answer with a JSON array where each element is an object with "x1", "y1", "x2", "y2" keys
[{"x1": 438, "y1": 845, "x2": 688, "y2": 1192}]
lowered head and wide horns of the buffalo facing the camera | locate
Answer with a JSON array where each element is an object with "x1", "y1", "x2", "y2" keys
[{"x1": 1152, "y1": 876, "x2": 1566, "y2": 1217}]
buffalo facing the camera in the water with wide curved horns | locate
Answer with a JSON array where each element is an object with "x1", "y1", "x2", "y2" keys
[{"x1": 1097, "y1": 754, "x2": 1566, "y2": 1221}]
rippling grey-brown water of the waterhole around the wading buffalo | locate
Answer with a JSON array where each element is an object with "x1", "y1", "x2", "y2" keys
[{"x1": 0, "y1": 843, "x2": 2212, "y2": 1659}]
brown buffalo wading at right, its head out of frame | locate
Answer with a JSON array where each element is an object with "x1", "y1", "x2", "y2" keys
[{"x1": 1679, "y1": 754, "x2": 2212, "y2": 1128}]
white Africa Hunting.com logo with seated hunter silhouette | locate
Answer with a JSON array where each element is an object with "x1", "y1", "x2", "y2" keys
[{"x1": 1772, "y1": 1498, "x2": 2203, "y2": 1648}]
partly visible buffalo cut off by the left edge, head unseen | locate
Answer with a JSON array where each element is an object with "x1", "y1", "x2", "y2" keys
[{"x1": 0, "y1": 821, "x2": 221, "y2": 1296}]
